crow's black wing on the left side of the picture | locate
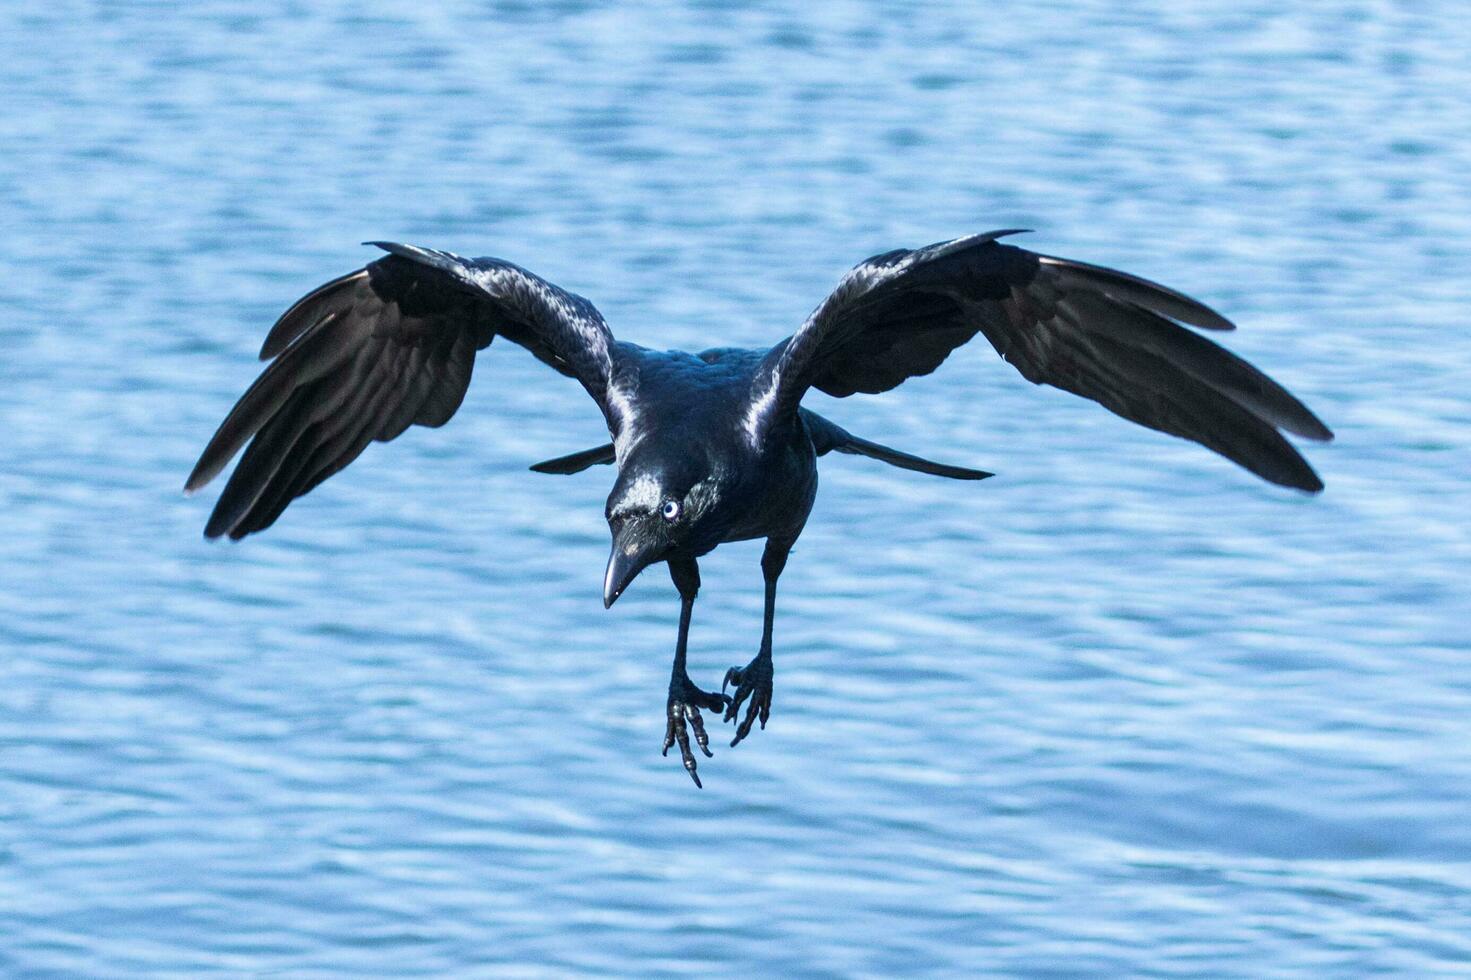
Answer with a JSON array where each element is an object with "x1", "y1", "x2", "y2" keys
[{"x1": 184, "y1": 241, "x2": 619, "y2": 539}]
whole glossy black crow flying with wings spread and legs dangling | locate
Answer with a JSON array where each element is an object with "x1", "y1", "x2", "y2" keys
[{"x1": 184, "y1": 230, "x2": 1333, "y2": 786}]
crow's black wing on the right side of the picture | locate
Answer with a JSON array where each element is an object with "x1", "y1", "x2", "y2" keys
[{"x1": 747, "y1": 231, "x2": 1333, "y2": 491}]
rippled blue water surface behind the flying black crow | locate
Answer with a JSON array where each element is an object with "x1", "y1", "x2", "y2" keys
[{"x1": 0, "y1": 0, "x2": 1471, "y2": 977}]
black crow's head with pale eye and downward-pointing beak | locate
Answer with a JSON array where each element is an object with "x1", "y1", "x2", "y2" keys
[{"x1": 603, "y1": 458, "x2": 721, "y2": 606}]
